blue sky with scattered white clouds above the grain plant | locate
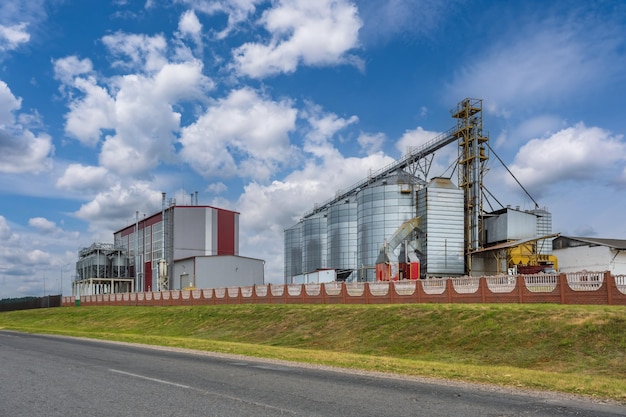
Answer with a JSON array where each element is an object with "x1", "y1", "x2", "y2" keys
[{"x1": 0, "y1": 0, "x2": 626, "y2": 298}]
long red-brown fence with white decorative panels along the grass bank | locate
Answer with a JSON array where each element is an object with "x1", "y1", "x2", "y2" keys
[{"x1": 63, "y1": 272, "x2": 626, "y2": 306}]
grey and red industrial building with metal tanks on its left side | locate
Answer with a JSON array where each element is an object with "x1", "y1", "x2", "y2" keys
[{"x1": 72, "y1": 194, "x2": 265, "y2": 295}]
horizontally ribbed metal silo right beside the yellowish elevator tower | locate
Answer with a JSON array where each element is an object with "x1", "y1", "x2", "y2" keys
[{"x1": 417, "y1": 178, "x2": 465, "y2": 277}]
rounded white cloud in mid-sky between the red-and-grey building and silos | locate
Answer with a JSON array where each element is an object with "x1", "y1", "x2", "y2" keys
[{"x1": 180, "y1": 88, "x2": 297, "y2": 179}]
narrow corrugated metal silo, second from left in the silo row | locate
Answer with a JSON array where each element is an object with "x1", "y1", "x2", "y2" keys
[{"x1": 302, "y1": 211, "x2": 328, "y2": 273}]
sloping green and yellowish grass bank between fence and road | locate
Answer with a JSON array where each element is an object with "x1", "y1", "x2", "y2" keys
[{"x1": 0, "y1": 304, "x2": 626, "y2": 403}]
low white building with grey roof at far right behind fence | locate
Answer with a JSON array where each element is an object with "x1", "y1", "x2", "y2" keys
[{"x1": 552, "y1": 236, "x2": 626, "y2": 275}]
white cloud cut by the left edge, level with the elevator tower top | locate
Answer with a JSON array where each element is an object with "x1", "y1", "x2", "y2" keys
[{"x1": 0, "y1": 80, "x2": 54, "y2": 173}]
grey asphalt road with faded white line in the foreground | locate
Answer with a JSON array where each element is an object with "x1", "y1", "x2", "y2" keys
[{"x1": 0, "y1": 331, "x2": 626, "y2": 417}]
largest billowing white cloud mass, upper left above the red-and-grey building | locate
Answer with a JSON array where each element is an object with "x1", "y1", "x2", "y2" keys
[{"x1": 55, "y1": 47, "x2": 208, "y2": 177}]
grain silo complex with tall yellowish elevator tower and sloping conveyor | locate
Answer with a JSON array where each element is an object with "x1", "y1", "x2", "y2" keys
[{"x1": 284, "y1": 98, "x2": 556, "y2": 283}]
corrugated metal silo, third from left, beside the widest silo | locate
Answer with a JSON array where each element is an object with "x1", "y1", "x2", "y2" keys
[{"x1": 327, "y1": 195, "x2": 357, "y2": 280}]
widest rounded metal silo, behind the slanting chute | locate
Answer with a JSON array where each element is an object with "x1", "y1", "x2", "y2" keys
[{"x1": 356, "y1": 173, "x2": 416, "y2": 281}]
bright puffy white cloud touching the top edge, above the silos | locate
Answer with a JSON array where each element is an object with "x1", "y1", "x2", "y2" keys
[{"x1": 233, "y1": 0, "x2": 362, "y2": 78}]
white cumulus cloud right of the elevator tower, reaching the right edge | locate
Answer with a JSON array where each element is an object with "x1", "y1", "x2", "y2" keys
[{"x1": 509, "y1": 123, "x2": 626, "y2": 196}]
